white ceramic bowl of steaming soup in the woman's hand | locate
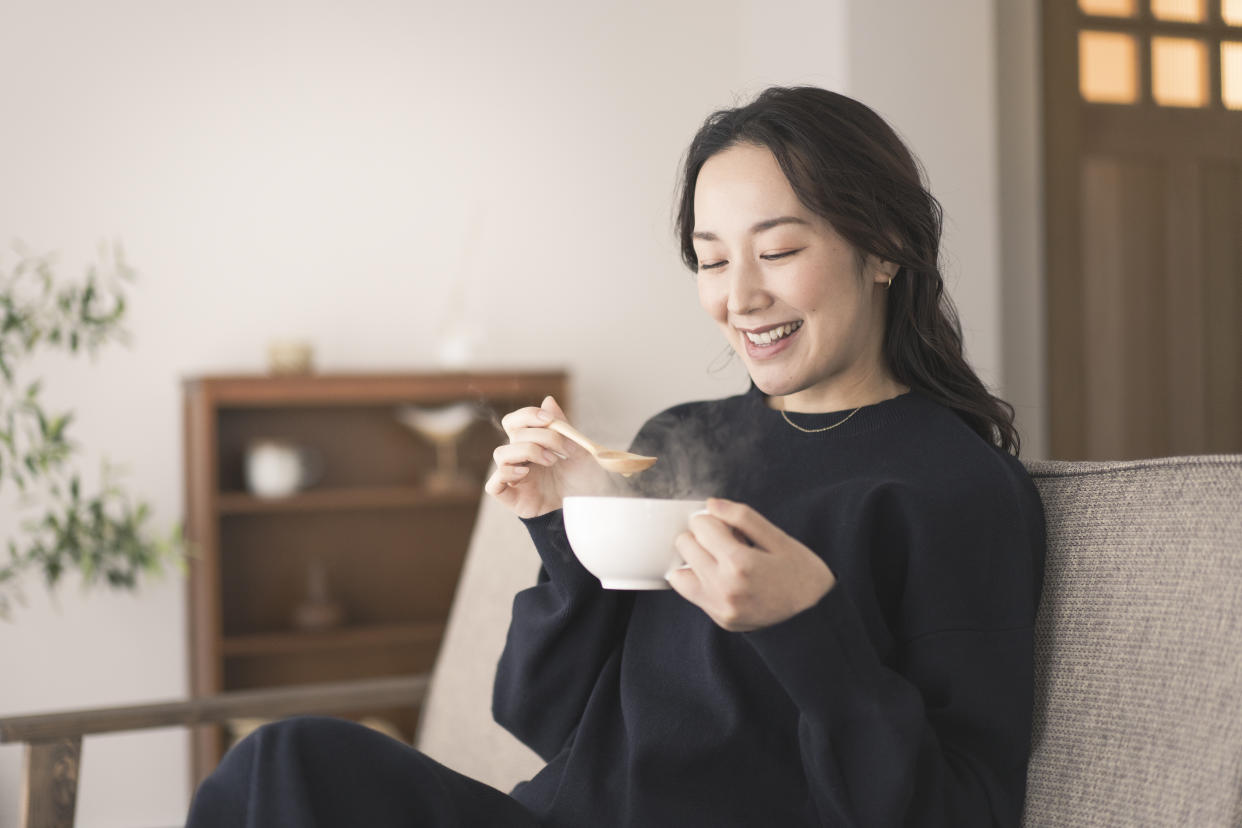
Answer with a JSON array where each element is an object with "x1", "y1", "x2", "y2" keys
[{"x1": 564, "y1": 497, "x2": 707, "y2": 590}]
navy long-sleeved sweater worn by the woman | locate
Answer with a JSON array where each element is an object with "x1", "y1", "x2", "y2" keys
[{"x1": 493, "y1": 386, "x2": 1045, "y2": 828}]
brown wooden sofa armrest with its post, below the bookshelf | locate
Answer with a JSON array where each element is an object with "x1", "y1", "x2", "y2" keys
[{"x1": 0, "y1": 675, "x2": 427, "y2": 828}]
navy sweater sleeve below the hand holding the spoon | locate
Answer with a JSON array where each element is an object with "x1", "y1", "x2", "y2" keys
[{"x1": 492, "y1": 509, "x2": 632, "y2": 761}]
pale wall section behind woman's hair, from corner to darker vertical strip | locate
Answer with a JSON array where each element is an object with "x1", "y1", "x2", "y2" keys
[{"x1": 850, "y1": 0, "x2": 1001, "y2": 389}]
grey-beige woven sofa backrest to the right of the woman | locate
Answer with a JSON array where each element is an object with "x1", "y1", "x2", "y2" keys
[{"x1": 1025, "y1": 454, "x2": 1242, "y2": 828}]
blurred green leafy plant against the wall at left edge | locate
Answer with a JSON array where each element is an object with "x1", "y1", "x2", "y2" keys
[{"x1": 0, "y1": 245, "x2": 186, "y2": 618}]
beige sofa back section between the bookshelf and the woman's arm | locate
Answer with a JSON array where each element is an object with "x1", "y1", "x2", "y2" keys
[{"x1": 415, "y1": 494, "x2": 543, "y2": 791}]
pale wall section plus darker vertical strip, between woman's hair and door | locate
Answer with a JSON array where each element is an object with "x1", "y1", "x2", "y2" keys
[{"x1": 847, "y1": 0, "x2": 1047, "y2": 457}]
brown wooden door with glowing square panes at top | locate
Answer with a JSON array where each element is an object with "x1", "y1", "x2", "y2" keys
[{"x1": 1043, "y1": 0, "x2": 1242, "y2": 459}]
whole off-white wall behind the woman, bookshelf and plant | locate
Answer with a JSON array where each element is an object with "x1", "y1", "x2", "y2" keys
[{"x1": 0, "y1": 0, "x2": 1038, "y2": 828}]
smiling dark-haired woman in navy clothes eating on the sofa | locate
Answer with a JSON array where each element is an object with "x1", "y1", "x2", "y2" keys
[{"x1": 186, "y1": 88, "x2": 1043, "y2": 828}]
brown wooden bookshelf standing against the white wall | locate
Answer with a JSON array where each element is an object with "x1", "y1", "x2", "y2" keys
[{"x1": 184, "y1": 371, "x2": 566, "y2": 785}]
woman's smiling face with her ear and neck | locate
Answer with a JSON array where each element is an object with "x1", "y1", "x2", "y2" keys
[{"x1": 694, "y1": 144, "x2": 899, "y2": 411}]
